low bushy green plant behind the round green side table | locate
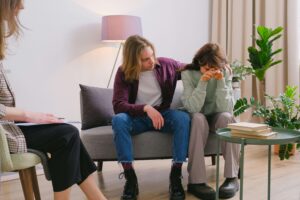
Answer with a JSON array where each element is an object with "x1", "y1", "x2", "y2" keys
[{"x1": 234, "y1": 86, "x2": 300, "y2": 160}]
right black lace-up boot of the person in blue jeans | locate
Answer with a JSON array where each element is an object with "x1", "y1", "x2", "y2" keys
[{"x1": 169, "y1": 166, "x2": 185, "y2": 200}]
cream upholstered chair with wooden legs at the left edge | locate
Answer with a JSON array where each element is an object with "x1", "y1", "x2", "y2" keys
[{"x1": 0, "y1": 127, "x2": 50, "y2": 200}]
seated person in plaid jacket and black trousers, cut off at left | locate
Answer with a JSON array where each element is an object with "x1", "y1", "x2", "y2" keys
[{"x1": 0, "y1": 0, "x2": 106, "y2": 200}]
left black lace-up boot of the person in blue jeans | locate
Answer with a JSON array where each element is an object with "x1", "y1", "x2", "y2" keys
[{"x1": 120, "y1": 169, "x2": 139, "y2": 200}]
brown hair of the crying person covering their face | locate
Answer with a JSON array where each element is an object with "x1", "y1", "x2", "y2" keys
[{"x1": 185, "y1": 43, "x2": 228, "y2": 70}]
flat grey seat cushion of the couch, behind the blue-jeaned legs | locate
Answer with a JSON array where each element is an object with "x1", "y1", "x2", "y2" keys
[{"x1": 81, "y1": 126, "x2": 173, "y2": 160}]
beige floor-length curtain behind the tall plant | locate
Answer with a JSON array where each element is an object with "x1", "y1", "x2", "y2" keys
[{"x1": 211, "y1": 0, "x2": 299, "y2": 101}]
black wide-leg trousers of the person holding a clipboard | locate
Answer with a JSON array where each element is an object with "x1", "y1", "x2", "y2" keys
[{"x1": 19, "y1": 124, "x2": 96, "y2": 192}]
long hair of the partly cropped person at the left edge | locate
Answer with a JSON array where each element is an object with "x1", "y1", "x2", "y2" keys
[{"x1": 0, "y1": 0, "x2": 23, "y2": 60}]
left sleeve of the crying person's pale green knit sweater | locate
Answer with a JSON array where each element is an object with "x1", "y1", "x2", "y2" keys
[{"x1": 181, "y1": 70, "x2": 207, "y2": 113}]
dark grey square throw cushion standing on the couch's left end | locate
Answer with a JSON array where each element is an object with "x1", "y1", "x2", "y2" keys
[{"x1": 79, "y1": 84, "x2": 113, "y2": 130}]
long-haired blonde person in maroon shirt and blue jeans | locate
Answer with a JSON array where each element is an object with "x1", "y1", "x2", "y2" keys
[{"x1": 112, "y1": 35, "x2": 190, "y2": 200}]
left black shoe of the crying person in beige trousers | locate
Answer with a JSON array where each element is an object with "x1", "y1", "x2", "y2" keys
[{"x1": 188, "y1": 183, "x2": 216, "y2": 200}]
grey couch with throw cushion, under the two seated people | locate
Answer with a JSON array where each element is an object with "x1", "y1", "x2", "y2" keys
[{"x1": 80, "y1": 81, "x2": 217, "y2": 171}]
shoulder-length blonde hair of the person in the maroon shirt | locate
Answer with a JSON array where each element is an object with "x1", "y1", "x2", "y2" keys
[{"x1": 121, "y1": 35, "x2": 156, "y2": 81}]
